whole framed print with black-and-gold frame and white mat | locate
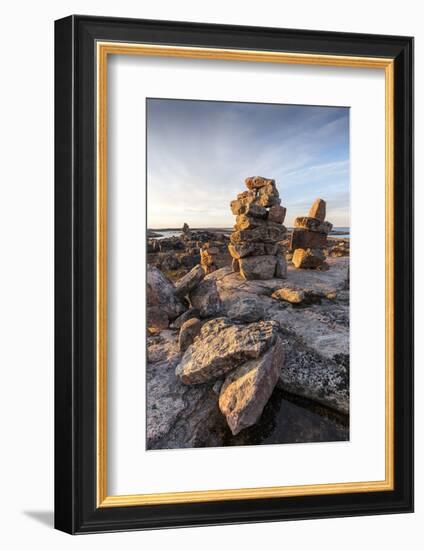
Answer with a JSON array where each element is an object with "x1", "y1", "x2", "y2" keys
[{"x1": 55, "y1": 16, "x2": 413, "y2": 534}]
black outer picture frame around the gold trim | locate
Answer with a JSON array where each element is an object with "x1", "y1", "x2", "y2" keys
[{"x1": 55, "y1": 15, "x2": 413, "y2": 534}]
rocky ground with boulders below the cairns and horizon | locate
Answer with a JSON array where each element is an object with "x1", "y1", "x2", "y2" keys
[{"x1": 147, "y1": 232, "x2": 349, "y2": 449}]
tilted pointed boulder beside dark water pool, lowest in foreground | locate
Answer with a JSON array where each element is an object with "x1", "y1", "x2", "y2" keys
[{"x1": 219, "y1": 338, "x2": 284, "y2": 435}]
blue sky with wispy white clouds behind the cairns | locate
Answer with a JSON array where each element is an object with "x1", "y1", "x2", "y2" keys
[{"x1": 147, "y1": 99, "x2": 349, "y2": 228}]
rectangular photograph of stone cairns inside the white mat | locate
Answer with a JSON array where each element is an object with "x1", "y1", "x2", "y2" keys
[{"x1": 146, "y1": 97, "x2": 351, "y2": 451}]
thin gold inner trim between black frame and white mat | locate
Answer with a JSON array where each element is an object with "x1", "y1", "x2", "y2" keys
[{"x1": 96, "y1": 41, "x2": 394, "y2": 507}]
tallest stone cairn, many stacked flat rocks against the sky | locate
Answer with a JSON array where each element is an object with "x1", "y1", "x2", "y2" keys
[{"x1": 228, "y1": 176, "x2": 287, "y2": 280}]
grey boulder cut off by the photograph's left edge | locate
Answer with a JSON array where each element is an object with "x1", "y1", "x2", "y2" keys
[{"x1": 147, "y1": 265, "x2": 186, "y2": 321}]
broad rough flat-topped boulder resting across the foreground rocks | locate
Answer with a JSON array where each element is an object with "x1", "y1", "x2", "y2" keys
[{"x1": 175, "y1": 317, "x2": 279, "y2": 384}]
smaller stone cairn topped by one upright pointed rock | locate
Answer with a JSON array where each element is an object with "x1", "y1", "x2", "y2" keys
[{"x1": 290, "y1": 199, "x2": 333, "y2": 269}]
